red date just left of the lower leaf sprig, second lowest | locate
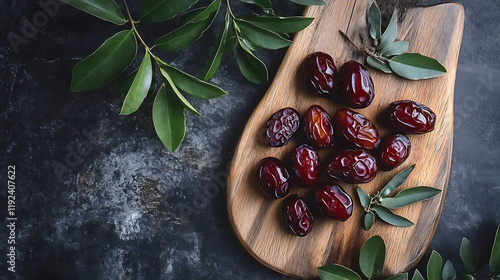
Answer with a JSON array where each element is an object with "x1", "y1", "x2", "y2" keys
[{"x1": 314, "y1": 183, "x2": 353, "y2": 221}]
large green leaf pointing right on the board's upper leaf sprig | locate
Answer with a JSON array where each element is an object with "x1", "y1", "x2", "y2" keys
[{"x1": 389, "y1": 53, "x2": 446, "y2": 80}]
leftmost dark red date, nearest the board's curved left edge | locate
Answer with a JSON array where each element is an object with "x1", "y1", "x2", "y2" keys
[{"x1": 258, "y1": 157, "x2": 290, "y2": 198}]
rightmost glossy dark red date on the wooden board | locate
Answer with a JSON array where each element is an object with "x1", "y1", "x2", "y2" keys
[{"x1": 386, "y1": 100, "x2": 436, "y2": 134}]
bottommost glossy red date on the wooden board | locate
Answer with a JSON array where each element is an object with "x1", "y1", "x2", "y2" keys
[{"x1": 281, "y1": 194, "x2": 313, "y2": 236}]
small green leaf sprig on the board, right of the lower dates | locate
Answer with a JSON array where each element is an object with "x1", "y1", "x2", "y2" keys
[{"x1": 356, "y1": 165, "x2": 441, "y2": 230}]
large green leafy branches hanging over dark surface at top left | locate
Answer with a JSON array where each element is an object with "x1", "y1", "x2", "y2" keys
[{"x1": 63, "y1": 0, "x2": 323, "y2": 152}]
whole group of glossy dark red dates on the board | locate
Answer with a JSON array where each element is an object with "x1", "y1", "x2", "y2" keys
[{"x1": 258, "y1": 52, "x2": 436, "y2": 236}]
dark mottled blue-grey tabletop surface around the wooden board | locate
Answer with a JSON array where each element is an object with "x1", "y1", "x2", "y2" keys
[{"x1": 0, "y1": 0, "x2": 500, "y2": 280}]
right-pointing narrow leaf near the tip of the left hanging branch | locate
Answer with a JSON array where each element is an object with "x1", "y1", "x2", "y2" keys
[{"x1": 161, "y1": 64, "x2": 227, "y2": 99}]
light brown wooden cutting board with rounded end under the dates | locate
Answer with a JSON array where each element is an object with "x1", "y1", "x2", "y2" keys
[{"x1": 227, "y1": 0, "x2": 464, "y2": 278}]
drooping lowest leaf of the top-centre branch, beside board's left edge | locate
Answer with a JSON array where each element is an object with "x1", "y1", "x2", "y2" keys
[{"x1": 236, "y1": 42, "x2": 268, "y2": 84}]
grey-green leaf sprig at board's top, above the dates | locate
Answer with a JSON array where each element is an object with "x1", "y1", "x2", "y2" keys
[{"x1": 365, "y1": 1, "x2": 446, "y2": 80}]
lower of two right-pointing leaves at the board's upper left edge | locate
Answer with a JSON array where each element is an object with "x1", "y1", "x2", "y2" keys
[{"x1": 236, "y1": 19, "x2": 292, "y2": 50}]
